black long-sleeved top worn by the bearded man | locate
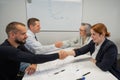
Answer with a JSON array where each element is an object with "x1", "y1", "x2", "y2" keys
[{"x1": 0, "y1": 40, "x2": 59, "y2": 80}]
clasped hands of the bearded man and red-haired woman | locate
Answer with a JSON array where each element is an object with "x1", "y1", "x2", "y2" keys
[{"x1": 58, "y1": 50, "x2": 75, "y2": 59}]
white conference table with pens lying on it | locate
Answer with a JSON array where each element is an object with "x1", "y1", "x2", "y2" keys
[{"x1": 23, "y1": 47, "x2": 118, "y2": 80}]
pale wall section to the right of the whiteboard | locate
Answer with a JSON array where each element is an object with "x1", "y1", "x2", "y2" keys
[{"x1": 83, "y1": 0, "x2": 120, "y2": 52}]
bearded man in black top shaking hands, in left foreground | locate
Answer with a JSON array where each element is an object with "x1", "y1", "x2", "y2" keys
[{"x1": 0, "y1": 22, "x2": 68, "y2": 80}]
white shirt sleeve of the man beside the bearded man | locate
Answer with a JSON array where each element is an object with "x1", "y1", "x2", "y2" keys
[{"x1": 25, "y1": 31, "x2": 58, "y2": 54}]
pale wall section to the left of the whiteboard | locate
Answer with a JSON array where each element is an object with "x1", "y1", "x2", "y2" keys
[{"x1": 0, "y1": 0, "x2": 27, "y2": 43}]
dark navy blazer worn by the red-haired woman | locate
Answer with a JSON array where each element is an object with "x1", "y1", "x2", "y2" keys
[{"x1": 74, "y1": 39, "x2": 120, "y2": 80}]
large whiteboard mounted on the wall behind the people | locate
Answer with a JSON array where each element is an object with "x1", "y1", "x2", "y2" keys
[{"x1": 27, "y1": 0, "x2": 82, "y2": 31}]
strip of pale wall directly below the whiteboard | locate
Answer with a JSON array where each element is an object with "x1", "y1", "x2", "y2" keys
[{"x1": 37, "y1": 32, "x2": 79, "y2": 44}]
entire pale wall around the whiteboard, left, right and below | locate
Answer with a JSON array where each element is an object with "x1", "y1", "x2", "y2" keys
[{"x1": 0, "y1": 0, "x2": 120, "y2": 50}]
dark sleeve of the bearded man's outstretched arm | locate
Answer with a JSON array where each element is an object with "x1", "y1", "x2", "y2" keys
[{"x1": 0, "y1": 46, "x2": 59, "y2": 64}]
